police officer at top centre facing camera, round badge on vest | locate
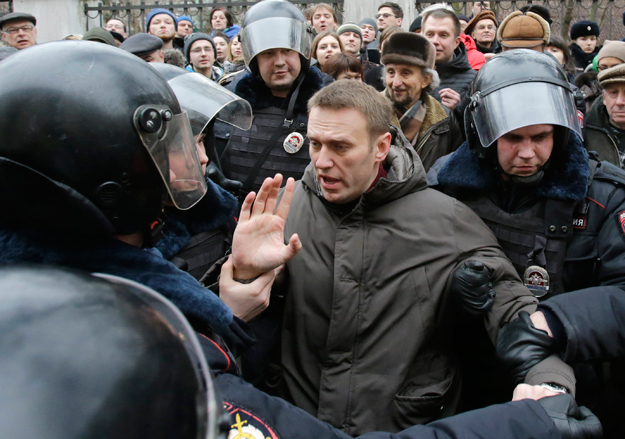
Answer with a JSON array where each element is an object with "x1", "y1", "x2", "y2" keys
[{"x1": 215, "y1": 0, "x2": 322, "y2": 198}]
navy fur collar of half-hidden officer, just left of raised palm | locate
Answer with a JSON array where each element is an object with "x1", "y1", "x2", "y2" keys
[{"x1": 155, "y1": 180, "x2": 238, "y2": 259}]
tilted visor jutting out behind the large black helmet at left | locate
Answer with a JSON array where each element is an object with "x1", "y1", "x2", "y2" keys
[{"x1": 168, "y1": 73, "x2": 252, "y2": 136}]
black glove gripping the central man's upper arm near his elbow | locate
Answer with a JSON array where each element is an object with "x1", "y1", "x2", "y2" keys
[{"x1": 451, "y1": 260, "x2": 495, "y2": 316}]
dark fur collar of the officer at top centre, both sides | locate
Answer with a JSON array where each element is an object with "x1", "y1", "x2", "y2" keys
[{"x1": 234, "y1": 68, "x2": 323, "y2": 113}]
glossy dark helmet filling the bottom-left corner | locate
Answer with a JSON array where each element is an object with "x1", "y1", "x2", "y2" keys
[{"x1": 0, "y1": 267, "x2": 224, "y2": 439}]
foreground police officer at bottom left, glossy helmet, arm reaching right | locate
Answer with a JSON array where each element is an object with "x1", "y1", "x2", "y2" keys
[{"x1": 0, "y1": 267, "x2": 601, "y2": 439}]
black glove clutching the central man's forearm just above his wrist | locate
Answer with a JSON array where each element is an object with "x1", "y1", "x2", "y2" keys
[{"x1": 497, "y1": 311, "x2": 556, "y2": 384}]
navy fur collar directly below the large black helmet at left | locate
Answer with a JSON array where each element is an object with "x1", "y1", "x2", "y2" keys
[{"x1": 0, "y1": 225, "x2": 233, "y2": 336}]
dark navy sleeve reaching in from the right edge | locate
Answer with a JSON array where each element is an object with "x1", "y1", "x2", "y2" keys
[{"x1": 539, "y1": 286, "x2": 625, "y2": 362}]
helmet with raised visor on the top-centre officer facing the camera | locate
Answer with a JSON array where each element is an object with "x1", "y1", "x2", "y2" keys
[{"x1": 241, "y1": 0, "x2": 312, "y2": 74}]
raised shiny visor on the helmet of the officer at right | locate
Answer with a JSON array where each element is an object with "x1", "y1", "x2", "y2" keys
[{"x1": 467, "y1": 82, "x2": 582, "y2": 148}]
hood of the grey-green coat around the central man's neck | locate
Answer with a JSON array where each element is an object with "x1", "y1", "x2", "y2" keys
[{"x1": 302, "y1": 125, "x2": 427, "y2": 206}]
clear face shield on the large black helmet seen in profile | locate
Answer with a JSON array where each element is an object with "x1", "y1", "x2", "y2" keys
[{"x1": 134, "y1": 105, "x2": 207, "y2": 210}]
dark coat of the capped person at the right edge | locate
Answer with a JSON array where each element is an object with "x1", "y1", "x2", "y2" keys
[{"x1": 584, "y1": 96, "x2": 625, "y2": 168}]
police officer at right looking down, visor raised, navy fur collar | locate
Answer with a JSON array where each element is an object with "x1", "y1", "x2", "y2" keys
[{"x1": 429, "y1": 49, "x2": 625, "y2": 436}]
